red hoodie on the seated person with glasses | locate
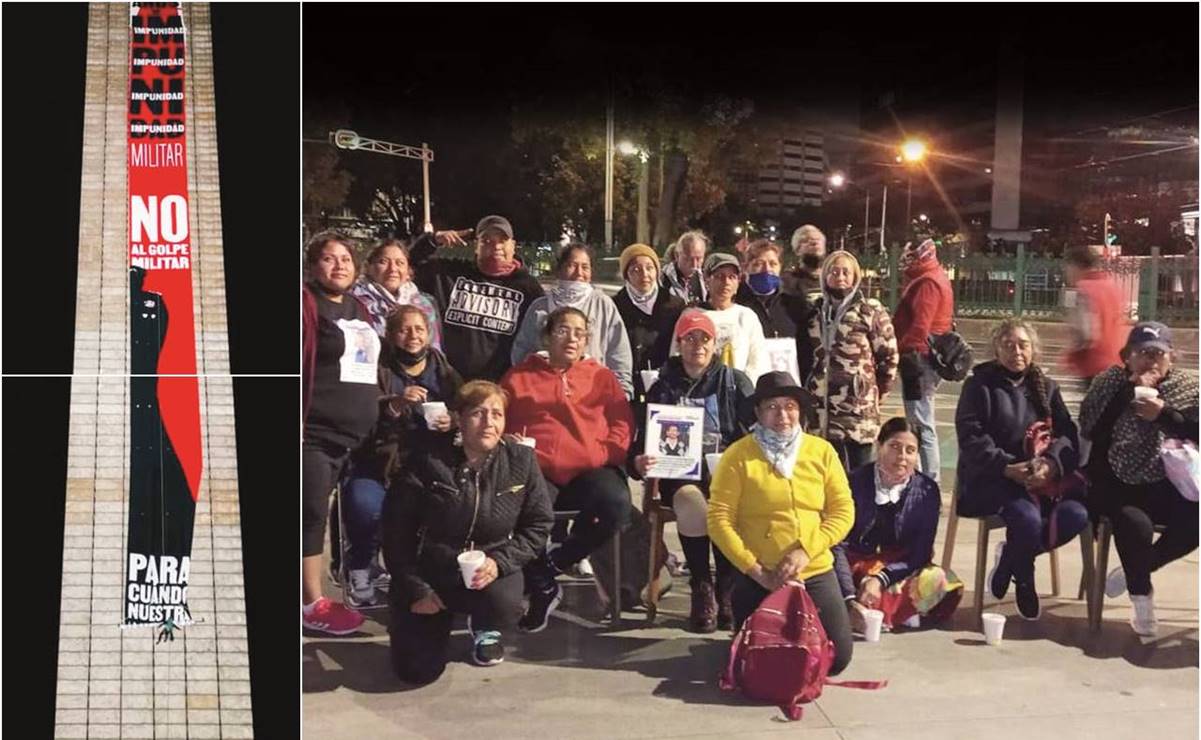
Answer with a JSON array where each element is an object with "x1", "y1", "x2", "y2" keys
[{"x1": 501, "y1": 352, "x2": 634, "y2": 485}]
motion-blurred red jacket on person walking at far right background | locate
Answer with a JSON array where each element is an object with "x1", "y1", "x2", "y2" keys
[{"x1": 1064, "y1": 270, "x2": 1129, "y2": 377}]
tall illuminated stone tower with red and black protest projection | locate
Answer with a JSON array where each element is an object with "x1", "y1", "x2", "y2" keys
[{"x1": 55, "y1": 4, "x2": 252, "y2": 738}]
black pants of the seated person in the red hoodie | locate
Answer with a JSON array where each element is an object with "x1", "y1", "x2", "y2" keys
[{"x1": 546, "y1": 467, "x2": 631, "y2": 568}]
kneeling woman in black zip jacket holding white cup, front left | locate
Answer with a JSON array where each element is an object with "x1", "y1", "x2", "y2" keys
[{"x1": 383, "y1": 381, "x2": 554, "y2": 684}]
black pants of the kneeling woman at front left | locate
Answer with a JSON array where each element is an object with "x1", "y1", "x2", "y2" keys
[{"x1": 388, "y1": 571, "x2": 525, "y2": 684}]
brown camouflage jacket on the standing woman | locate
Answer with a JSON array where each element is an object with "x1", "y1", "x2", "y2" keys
[{"x1": 806, "y1": 290, "x2": 898, "y2": 444}]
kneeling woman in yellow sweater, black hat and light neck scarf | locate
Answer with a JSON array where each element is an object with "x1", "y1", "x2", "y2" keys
[{"x1": 709, "y1": 372, "x2": 855, "y2": 675}]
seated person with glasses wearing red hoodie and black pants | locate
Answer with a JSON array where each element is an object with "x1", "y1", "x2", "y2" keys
[{"x1": 501, "y1": 306, "x2": 634, "y2": 632}]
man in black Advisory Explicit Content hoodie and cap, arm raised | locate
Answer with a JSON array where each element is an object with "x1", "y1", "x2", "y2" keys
[{"x1": 410, "y1": 216, "x2": 543, "y2": 381}]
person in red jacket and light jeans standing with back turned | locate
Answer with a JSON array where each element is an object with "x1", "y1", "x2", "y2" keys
[{"x1": 892, "y1": 239, "x2": 955, "y2": 483}]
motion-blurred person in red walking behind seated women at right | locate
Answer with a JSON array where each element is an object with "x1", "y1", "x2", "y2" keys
[{"x1": 1063, "y1": 246, "x2": 1129, "y2": 387}]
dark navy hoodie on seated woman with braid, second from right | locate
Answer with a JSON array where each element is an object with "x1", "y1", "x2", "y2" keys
[{"x1": 955, "y1": 360, "x2": 1080, "y2": 517}]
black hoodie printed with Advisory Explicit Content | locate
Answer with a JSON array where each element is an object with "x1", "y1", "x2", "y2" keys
[{"x1": 410, "y1": 234, "x2": 543, "y2": 381}]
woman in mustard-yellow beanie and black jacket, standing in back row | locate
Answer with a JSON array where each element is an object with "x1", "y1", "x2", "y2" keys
[{"x1": 613, "y1": 244, "x2": 685, "y2": 403}]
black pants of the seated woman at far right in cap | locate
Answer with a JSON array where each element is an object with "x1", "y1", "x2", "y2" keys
[{"x1": 1097, "y1": 479, "x2": 1197, "y2": 596}]
